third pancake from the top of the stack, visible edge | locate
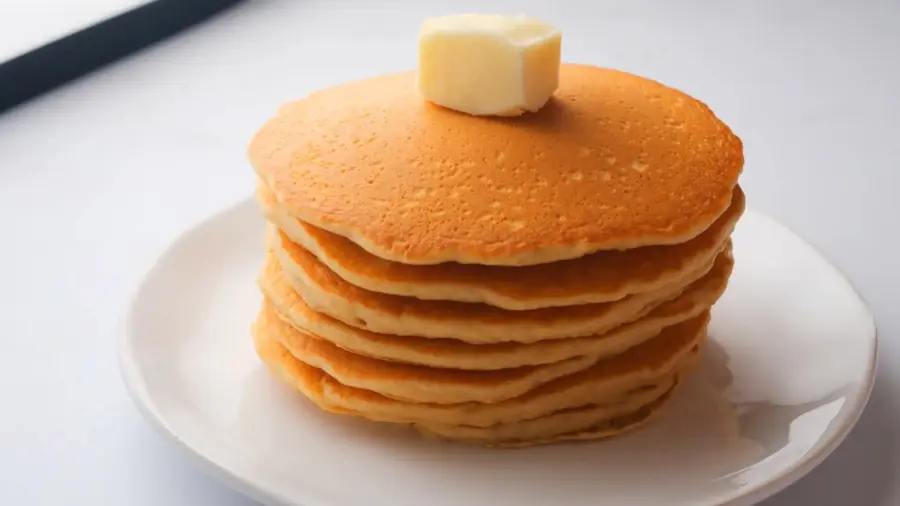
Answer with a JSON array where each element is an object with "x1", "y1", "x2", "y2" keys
[{"x1": 270, "y1": 231, "x2": 713, "y2": 344}]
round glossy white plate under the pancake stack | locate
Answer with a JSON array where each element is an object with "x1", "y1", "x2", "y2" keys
[{"x1": 120, "y1": 201, "x2": 876, "y2": 506}]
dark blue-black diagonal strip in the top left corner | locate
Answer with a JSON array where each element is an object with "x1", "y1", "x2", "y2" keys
[{"x1": 0, "y1": 0, "x2": 241, "y2": 113}]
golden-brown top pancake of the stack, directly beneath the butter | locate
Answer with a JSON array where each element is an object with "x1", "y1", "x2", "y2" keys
[{"x1": 248, "y1": 64, "x2": 743, "y2": 265}]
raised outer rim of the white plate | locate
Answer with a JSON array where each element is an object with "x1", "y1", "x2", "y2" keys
[{"x1": 116, "y1": 198, "x2": 879, "y2": 506}]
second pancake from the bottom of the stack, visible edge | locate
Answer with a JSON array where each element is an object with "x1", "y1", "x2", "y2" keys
[{"x1": 253, "y1": 311, "x2": 709, "y2": 427}]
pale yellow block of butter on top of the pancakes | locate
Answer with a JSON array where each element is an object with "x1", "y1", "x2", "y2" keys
[{"x1": 416, "y1": 14, "x2": 562, "y2": 116}]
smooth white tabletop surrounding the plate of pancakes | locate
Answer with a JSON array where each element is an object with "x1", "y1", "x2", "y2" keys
[{"x1": 0, "y1": 0, "x2": 900, "y2": 506}]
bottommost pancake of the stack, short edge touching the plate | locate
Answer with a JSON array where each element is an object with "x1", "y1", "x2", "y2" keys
[{"x1": 415, "y1": 378, "x2": 678, "y2": 448}]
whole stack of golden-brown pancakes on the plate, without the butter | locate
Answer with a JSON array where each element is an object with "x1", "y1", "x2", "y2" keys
[{"x1": 249, "y1": 64, "x2": 744, "y2": 446}]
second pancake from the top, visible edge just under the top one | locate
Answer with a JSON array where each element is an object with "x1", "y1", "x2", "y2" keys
[{"x1": 257, "y1": 184, "x2": 745, "y2": 310}]
